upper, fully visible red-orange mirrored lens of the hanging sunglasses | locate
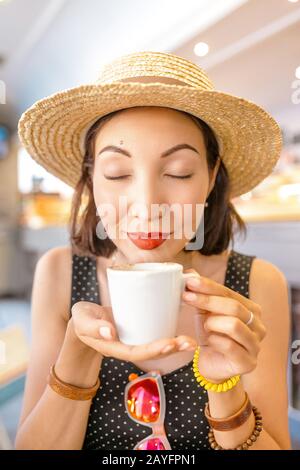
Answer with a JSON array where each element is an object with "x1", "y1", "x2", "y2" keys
[{"x1": 127, "y1": 378, "x2": 160, "y2": 423}]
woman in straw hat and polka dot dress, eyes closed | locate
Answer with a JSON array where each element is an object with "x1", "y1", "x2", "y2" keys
[{"x1": 16, "y1": 52, "x2": 290, "y2": 450}]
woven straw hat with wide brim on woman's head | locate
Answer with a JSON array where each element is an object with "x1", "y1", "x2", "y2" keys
[{"x1": 18, "y1": 51, "x2": 282, "y2": 197}]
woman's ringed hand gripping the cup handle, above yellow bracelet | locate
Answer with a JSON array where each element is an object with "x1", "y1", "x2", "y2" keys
[{"x1": 182, "y1": 269, "x2": 266, "y2": 382}]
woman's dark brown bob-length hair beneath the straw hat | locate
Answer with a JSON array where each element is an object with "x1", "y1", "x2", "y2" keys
[{"x1": 70, "y1": 110, "x2": 246, "y2": 257}]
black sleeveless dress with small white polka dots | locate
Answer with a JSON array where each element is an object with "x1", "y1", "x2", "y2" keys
[{"x1": 71, "y1": 250, "x2": 254, "y2": 450}]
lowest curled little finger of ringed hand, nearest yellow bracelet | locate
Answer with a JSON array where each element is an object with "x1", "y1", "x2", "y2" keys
[{"x1": 208, "y1": 333, "x2": 257, "y2": 375}]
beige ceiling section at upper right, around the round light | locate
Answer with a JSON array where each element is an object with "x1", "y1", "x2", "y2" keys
[{"x1": 175, "y1": 0, "x2": 300, "y2": 118}]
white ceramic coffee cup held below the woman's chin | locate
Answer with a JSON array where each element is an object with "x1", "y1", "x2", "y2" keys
[{"x1": 107, "y1": 262, "x2": 191, "y2": 345}]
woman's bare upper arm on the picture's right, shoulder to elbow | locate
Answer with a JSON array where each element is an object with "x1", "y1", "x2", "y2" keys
[{"x1": 243, "y1": 258, "x2": 291, "y2": 449}]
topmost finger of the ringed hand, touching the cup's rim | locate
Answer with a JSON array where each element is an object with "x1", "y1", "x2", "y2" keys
[{"x1": 184, "y1": 268, "x2": 261, "y2": 317}]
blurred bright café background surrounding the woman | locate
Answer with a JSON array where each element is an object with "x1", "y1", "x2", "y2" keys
[{"x1": 0, "y1": 0, "x2": 300, "y2": 449}]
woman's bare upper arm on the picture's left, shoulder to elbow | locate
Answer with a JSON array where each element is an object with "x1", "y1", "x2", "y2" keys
[{"x1": 16, "y1": 246, "x2": 72, "y2": 425}]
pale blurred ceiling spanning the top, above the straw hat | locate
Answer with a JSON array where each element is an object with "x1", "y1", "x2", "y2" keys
[{"x1": 0, "y1": 0, "x2": 300, "y2": 129}]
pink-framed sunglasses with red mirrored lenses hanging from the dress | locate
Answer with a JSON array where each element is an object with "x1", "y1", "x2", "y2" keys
[{"x1": 124, "y1": 371, "x2": 171, "y2": 450}]
